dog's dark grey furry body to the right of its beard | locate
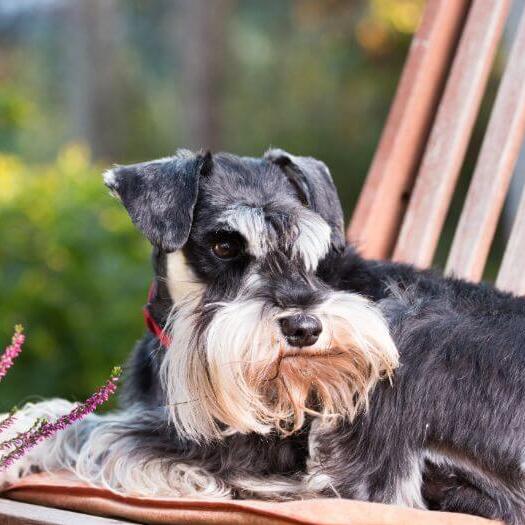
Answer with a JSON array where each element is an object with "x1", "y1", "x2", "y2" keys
[{"x1": 323, "y1": 253, "x2": 525, "y2": 523}]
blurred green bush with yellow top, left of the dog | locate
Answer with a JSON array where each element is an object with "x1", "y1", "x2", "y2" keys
[{"x1": 0, "y1": 145, "x2": 150, "y2": 410}]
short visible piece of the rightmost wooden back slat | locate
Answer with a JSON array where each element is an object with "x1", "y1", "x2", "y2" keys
[{"x1": 496, "y1": 185, "x2": 525, "y2": 295}]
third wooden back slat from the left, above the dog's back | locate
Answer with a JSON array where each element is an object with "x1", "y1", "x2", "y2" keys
[{"x1": 446, "y1": 8, "x2": 525, "y2": 281}]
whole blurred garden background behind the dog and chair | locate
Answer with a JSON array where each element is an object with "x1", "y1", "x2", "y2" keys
[{"x1": 0, "y1": 0, "x2": 521, "y2": 410}]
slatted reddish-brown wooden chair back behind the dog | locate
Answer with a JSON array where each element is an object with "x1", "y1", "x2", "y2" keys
[{"x1": 348, "y1": 0, "x2": 525, "y2": 294}]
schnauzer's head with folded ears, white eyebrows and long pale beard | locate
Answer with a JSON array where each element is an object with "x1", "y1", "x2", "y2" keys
[{"x1": 105, "y1": 150, "x2": 397, "y2": 440}]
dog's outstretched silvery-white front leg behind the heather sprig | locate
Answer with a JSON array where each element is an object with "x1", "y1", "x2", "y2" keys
[{"x1": 0, "y1": 399, "x2": 231, "y2": 499}]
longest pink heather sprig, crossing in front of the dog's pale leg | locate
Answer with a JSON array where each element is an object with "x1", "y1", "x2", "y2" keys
[{"x1": 0, "y1": 367, "x2": 121, "y2": 471}]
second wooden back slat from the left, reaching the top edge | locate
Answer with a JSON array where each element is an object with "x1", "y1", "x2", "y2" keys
[{"x1": 393, "y1": 0, "x2": 510, "y2": 268}]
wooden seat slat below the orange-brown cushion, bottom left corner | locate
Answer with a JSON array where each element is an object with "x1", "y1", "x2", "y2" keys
[{"x1": 0, "y1": 498, "x2": 131, "y2": 525}]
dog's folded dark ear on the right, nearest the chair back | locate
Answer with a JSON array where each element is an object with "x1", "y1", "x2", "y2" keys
[{"x1": 264, "y1": 149, "x2": 345, "y2": 249}]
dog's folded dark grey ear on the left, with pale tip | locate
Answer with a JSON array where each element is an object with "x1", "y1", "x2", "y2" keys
[{"x1": 104, "y1": 151, "x2": 212, "y2": 252}]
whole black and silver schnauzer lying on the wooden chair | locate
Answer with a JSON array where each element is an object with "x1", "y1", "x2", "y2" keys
[{"x1": 4, "y1": 150, "x2": 525, "y2": 524}]
